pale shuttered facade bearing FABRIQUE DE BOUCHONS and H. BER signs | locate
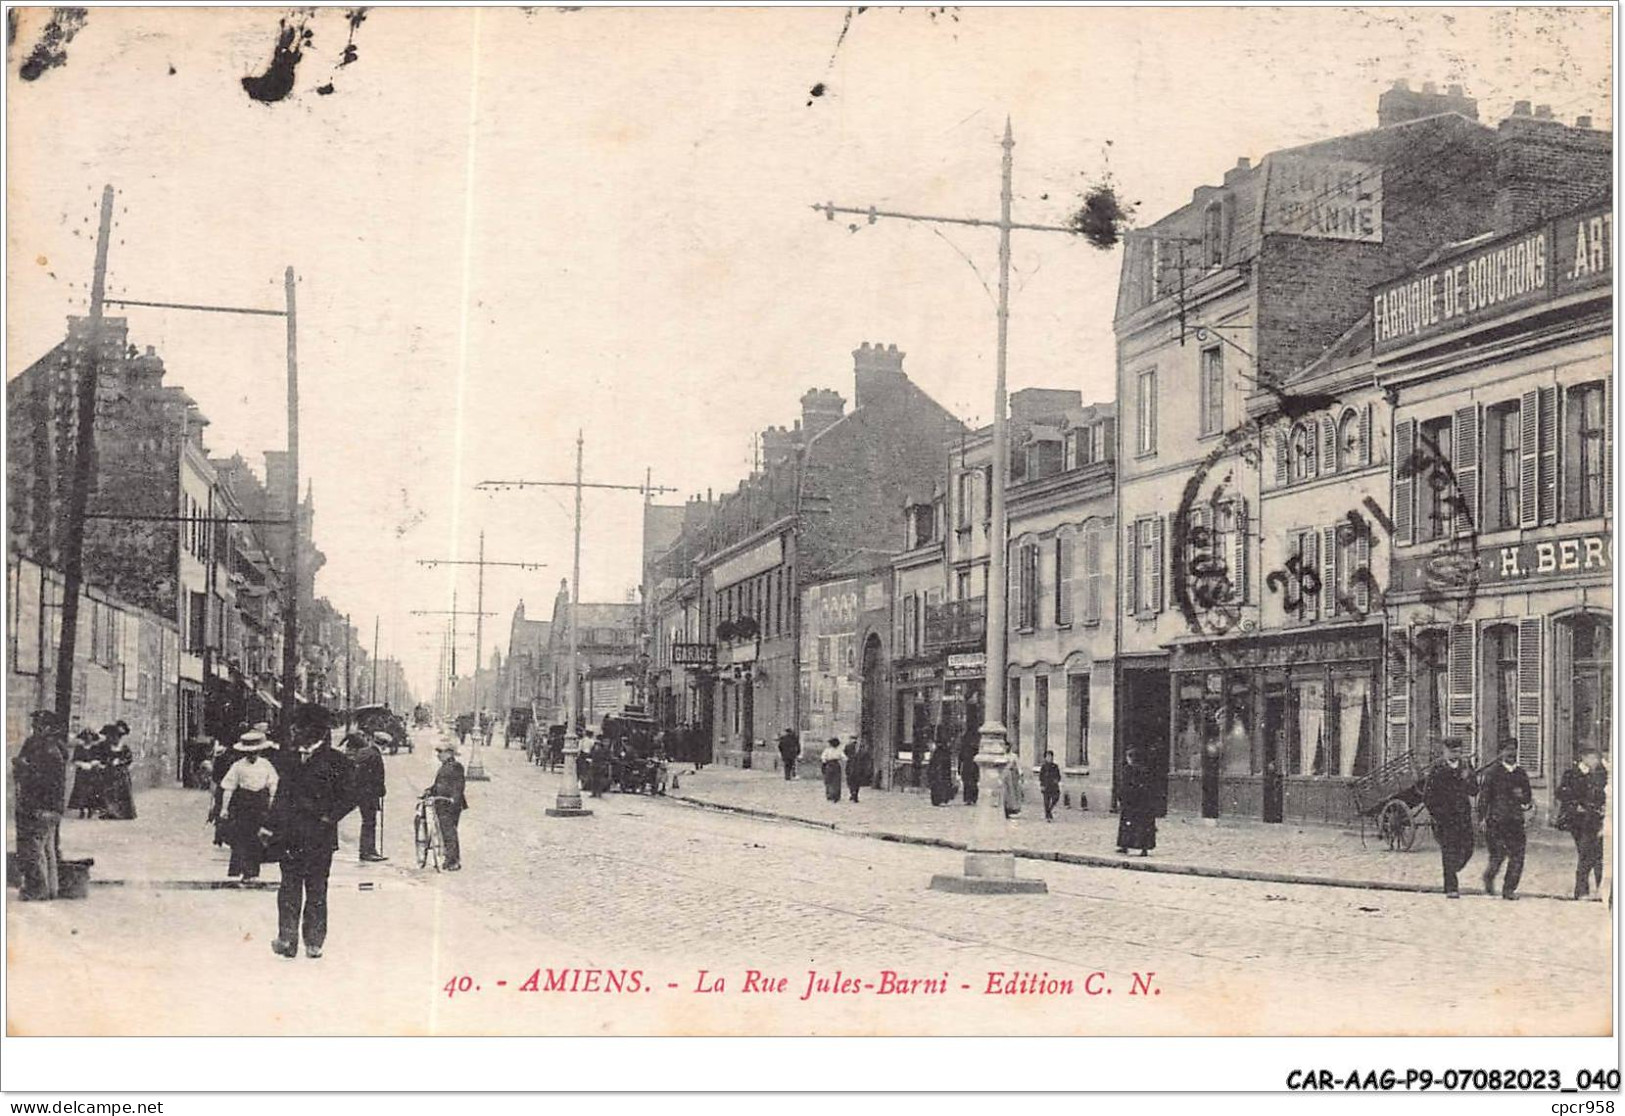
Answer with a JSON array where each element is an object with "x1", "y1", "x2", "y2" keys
[{"x1": 1373, "y1": 195, "x2": 1615, "y2": 815}]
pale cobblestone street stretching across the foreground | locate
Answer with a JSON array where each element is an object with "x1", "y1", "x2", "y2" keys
[{"x1": 10, "y1": 741, "x2": 1610, "y2": 1035}]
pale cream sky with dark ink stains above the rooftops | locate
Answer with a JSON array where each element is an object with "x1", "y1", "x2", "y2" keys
[{"x1": 5, "y1": 6, "x2": 1614, "y2": 695}]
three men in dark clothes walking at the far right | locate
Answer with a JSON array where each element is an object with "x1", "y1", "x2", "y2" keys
[{"x1": 1422, "y1": 738, "x2": 1609, "y2": 900}]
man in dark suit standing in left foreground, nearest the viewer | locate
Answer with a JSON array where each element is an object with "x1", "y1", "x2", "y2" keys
[{"x1": 265, "y1": 705, "x2": 356, "y2": 957}]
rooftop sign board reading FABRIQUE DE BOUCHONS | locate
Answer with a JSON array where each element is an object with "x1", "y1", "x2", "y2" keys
[{"x1": 1372, "y1": 210, "x2": 1614, "y2": 353}]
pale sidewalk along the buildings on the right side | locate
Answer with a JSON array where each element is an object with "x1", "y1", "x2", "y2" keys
[{"x1": 670, "y1": 765, "x2": 1575, "y2": 898}]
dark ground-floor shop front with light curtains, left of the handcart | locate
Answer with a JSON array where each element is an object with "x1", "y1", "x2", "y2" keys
[{"x1": 1168, "y1": 624, "x2": 1383, "y2": 824}]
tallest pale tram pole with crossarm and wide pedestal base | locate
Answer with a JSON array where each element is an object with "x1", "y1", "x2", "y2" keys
[{"x1": 813, "y1": 119, "x2": 1076, "y2": 893}]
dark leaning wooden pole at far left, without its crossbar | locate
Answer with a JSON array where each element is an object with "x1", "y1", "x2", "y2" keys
[{"x1": 57, "y1": 185, "x2": 112, "y2": 731}]
